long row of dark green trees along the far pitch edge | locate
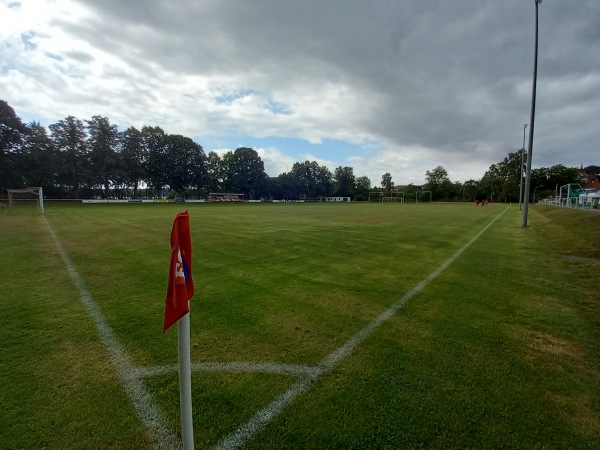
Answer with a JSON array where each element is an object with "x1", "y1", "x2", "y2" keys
[{"x1": 0, "y1": 100, "x2": 597, "y2": 201}]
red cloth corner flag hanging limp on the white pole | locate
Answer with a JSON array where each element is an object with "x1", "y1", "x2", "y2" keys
[{"x1": 163, "y1": 210, "x2": 194, "y2": 332}]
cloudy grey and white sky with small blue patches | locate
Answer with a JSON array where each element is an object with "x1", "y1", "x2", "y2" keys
[{"x1": 0, "y1": 0, "x2": 600, "y2": 185}]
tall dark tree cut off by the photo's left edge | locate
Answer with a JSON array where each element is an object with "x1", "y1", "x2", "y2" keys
[{"x1": 0, "y1": 100, "x2": 28, "y2": 187}]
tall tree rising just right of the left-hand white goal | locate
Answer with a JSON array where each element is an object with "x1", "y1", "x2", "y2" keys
[{"x1": 49, "y1": 116, "x2": 91, "y2": 198}]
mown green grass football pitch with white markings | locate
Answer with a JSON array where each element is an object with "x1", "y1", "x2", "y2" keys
[{"x1": 0, "y1": 204, "x2": 600, "y2": 449}]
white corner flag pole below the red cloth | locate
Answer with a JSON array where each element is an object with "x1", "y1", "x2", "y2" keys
[{"x1": 177, "y1": 312, "x2": 194, "y2": 450}]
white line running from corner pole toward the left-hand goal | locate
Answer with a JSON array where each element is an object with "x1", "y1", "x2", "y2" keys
[{"x1": 44, "y1": 217, "x2": 181, "y2": 449}]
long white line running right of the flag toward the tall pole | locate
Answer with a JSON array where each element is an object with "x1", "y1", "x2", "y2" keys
[{"x1": 215, "y1": 207, "x2": 510, "y2": 450}]
